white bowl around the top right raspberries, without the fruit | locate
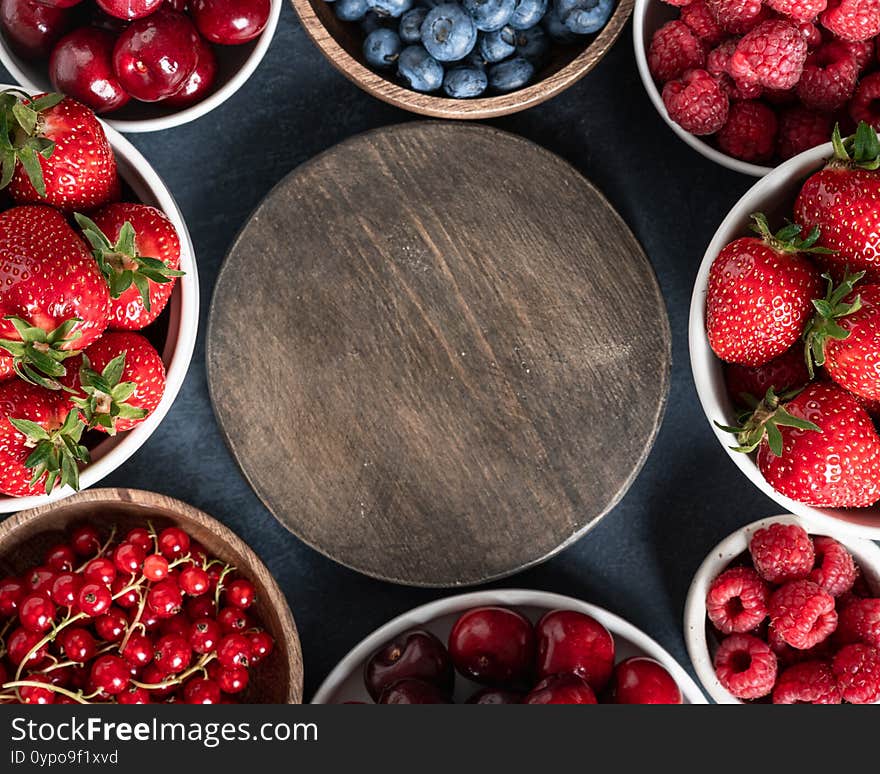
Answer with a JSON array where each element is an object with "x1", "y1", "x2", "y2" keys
[{"x1": 633, "y1": 0, "x2": 773, "y2": 177}]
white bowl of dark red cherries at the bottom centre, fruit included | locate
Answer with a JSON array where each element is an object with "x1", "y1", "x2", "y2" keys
[{"x1": 312, "y1": 589, "x2": 706, "y2": 704}]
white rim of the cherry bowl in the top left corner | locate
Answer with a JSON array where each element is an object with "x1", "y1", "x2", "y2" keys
[{"x1": 0, "y1": 0, "x2": 284, "y2": 134}]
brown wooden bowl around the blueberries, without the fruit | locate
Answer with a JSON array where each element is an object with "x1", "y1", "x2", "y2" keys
[{"x1": 291, "y1": 0, "x2": 634, "y2": 120}]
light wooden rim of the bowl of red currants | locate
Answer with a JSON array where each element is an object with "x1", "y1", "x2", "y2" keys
[{"x1": 0, "y1": 487, "x2": 304, "y2": 704}]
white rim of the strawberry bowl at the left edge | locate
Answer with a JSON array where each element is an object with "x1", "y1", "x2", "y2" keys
[{"x1": 0, "y1": 84, "x2": 199, "y2": 513}]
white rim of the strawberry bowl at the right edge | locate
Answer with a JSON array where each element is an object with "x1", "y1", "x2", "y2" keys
[{"x1": 688, "y1": 142, "x2": 880, "y2": 540}]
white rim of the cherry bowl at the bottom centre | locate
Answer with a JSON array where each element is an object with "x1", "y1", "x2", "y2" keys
[{"x1": 311, "y1": 588, "x2": 708, "y2": 704}]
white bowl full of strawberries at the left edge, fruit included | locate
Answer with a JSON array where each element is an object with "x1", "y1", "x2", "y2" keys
[{"x1": 0, "y1": 90, "x2": 199, "y2": 512}]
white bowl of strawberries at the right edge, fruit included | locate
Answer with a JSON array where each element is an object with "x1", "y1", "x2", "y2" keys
[{"x1": 689, "y1": 124, "x2": 880, "y2": 539}]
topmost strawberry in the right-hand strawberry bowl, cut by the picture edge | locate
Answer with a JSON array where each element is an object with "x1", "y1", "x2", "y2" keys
[{"x1": 794, "y1": 123, "x2": 880, "y2": 282}]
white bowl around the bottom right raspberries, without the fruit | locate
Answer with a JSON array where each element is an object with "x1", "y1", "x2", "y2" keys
[{"x1": 684, "y1": 514, "x2": 880, "y2": 704}]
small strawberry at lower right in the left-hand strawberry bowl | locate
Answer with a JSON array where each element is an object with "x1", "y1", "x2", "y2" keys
[{"x1": 63, "y1": 331, "x2": 165, "y2": 435}]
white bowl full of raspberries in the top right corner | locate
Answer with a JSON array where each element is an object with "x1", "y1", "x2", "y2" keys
[{"x1": 633, "y1": 0, "x2": 880, "y2": 177}]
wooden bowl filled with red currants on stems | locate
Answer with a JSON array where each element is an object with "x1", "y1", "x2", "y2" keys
[{"x1": 0, "y1": 489, "x2": 303, "y2": 704}]
